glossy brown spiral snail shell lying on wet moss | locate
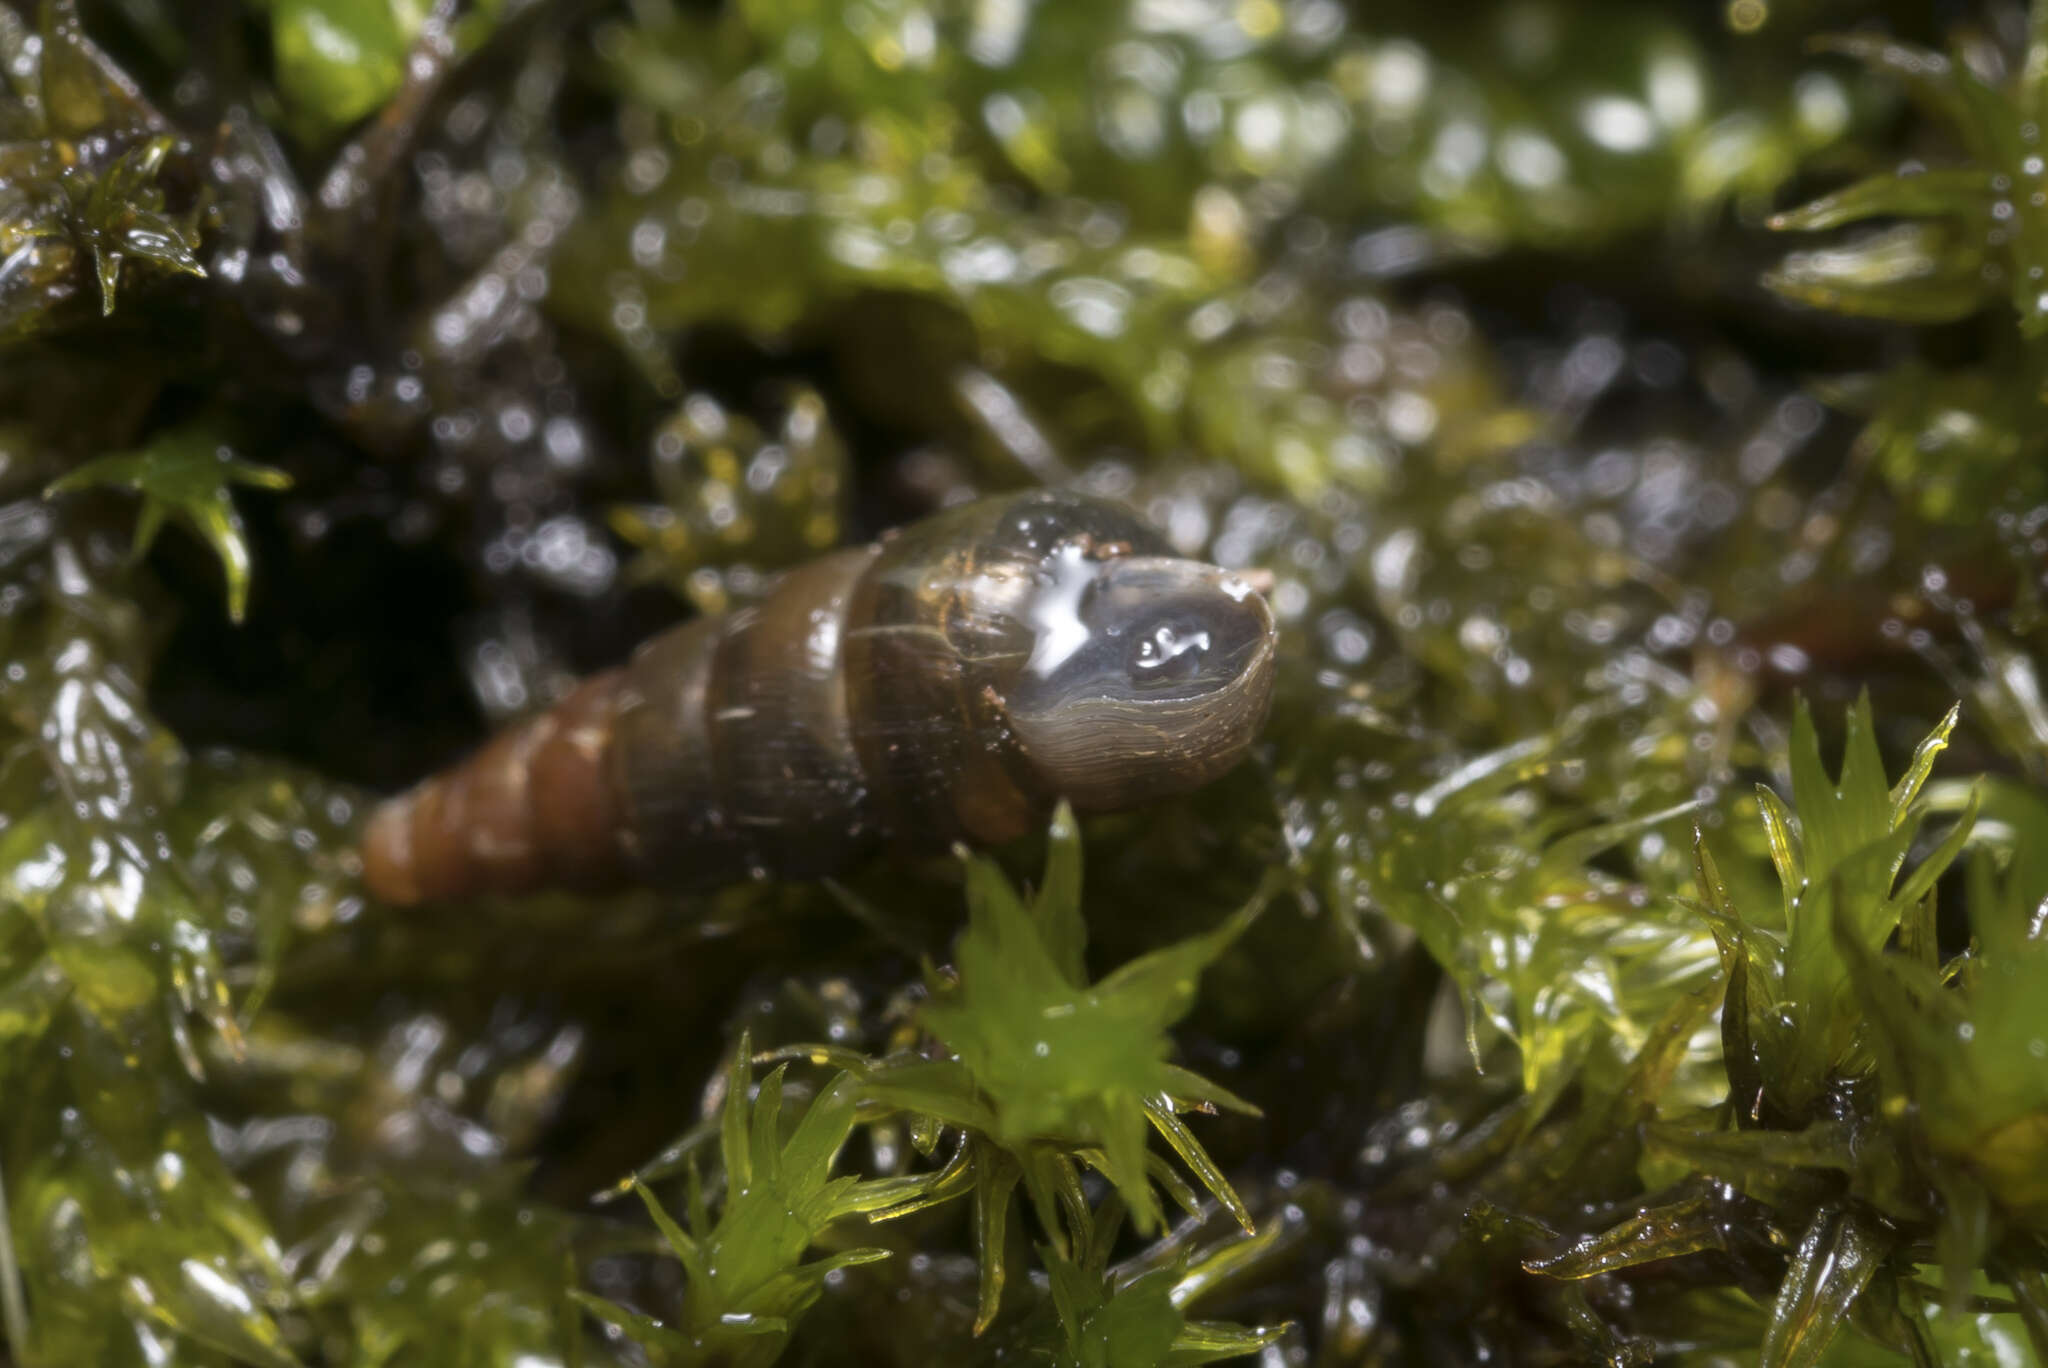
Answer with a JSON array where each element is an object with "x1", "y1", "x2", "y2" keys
[{"x1": 362, "y1": 491, "x2": 1276, "y2": 903}]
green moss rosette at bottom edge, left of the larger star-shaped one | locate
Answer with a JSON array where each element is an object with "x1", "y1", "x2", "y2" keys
[{"x1": 573, "y1": 1036, "x2": 938, "y2": 1368}]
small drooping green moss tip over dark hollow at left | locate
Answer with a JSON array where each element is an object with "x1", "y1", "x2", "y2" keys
[{"x1": 47, "y1": 424, "x2": 291, "y2": 623}]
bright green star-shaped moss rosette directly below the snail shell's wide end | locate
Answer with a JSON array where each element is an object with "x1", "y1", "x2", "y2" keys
[{"x1": 786, "y1": 805, "x2": 1264, "y2": 1331}]
